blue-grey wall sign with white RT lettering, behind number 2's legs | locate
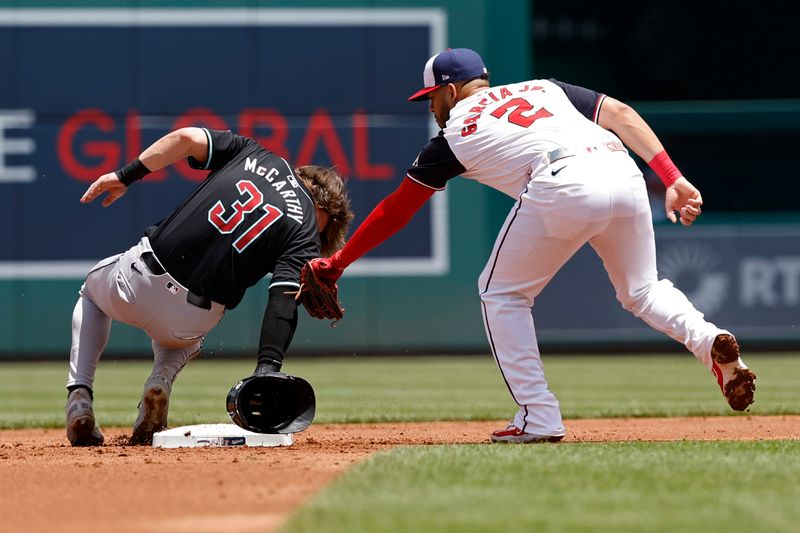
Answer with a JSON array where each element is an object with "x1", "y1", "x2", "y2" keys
[{"x1": 533, "y1": 224, "x2": 800, "y2": 342}]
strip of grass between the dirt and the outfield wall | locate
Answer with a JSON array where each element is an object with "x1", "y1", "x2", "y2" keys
[{"x1": 0, "y1": 354, "x2": 800, "y2": 428}]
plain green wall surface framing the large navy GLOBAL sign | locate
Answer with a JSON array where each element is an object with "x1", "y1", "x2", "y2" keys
[{"x1": 0, "y1": 0, "x2": 530, "y2": 357}]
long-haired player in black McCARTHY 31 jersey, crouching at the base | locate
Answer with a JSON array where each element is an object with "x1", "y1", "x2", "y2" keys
[{"x1": 66, "y1": 128, "x2": 352, "y2": 446}]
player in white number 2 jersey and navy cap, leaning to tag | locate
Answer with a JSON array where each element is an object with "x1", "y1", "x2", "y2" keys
[{"x1": 310, "y1": 48, "x2": 756, "y2": 443}]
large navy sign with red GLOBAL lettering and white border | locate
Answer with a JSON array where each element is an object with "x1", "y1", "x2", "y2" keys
[{"x1": 0, "y1": 9, "x2": 448, "y2": 278}]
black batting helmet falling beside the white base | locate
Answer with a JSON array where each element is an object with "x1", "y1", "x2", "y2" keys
[{"x1": 226, "y1": 372, "x2": 317, "y2": 433}]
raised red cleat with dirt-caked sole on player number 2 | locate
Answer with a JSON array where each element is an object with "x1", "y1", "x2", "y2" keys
[{"x1": 711, "y1": 333, "x2": 756, "y2": 411}]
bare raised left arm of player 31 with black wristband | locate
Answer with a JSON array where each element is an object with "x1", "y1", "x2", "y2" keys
[{"x1": 81, "y1": 128, "x2": 208, "y2": 207}]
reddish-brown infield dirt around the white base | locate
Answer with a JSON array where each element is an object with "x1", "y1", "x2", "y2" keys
[{"x1": 0, "y1": 416, "x2": 800, "y2": 532}]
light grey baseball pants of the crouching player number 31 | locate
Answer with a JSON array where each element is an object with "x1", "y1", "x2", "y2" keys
[{"x1": 67, "y1": 237, "x2": 225, "y2": 388}]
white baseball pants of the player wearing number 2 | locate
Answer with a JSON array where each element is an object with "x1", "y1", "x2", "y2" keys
[{"x1": 479, "y1": 151, "x2": 724, "y2": 436}]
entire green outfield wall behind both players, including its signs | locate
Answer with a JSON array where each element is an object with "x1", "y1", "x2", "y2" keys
[{"x1": 0, "y1": 0, "x2": 800, "y2": 359}]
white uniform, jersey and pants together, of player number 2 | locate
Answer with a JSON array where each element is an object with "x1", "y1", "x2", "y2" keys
[{"x1": 408, "y1": 80, "x2": 725, "y2": 436}]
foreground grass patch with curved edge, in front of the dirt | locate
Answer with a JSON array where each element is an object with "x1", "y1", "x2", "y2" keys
[{"x1": 282, "y1": 441, "x2": 800, "y2": 533}]
